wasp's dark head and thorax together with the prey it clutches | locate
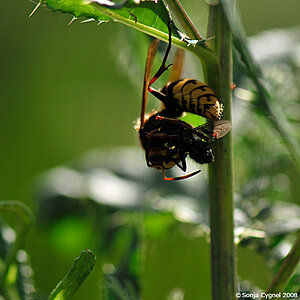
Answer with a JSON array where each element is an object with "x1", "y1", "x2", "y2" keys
[{"x1": 139, "y1": 110, "x2": 231, "y2": 180}]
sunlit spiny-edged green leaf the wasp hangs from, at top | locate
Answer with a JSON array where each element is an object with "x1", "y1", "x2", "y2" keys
[{"x1": 37, "y1": 0, "x2": 218, "y2": 65}]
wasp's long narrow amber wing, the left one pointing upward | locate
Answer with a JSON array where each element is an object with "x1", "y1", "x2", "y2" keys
[{"x1": 140, "y1": 39, "x2": 159, "y2": 127}]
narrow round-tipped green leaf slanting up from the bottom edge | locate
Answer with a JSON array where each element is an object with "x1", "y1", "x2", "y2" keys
[{"x1": 48, "y1": 249, "x2": 96, "y2": 300}]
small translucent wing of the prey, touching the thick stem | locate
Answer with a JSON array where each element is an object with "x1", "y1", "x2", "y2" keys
[{"x1": 195, "y1": 120, "x2": 232, "y2": 139}]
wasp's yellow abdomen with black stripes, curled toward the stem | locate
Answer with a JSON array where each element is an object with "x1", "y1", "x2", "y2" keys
[{"x1": 167, "y1": 79, "x2": 223, "y2": 120}]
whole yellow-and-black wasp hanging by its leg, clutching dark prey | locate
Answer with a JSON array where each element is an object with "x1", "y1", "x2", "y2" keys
[{"x1": 138, "y1": 25, "x2": 231, "y2": 180}]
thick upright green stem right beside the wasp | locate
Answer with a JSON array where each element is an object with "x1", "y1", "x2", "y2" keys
[{"x1": 207, "y1": 5, "x2": 236, "y2": 300}]
